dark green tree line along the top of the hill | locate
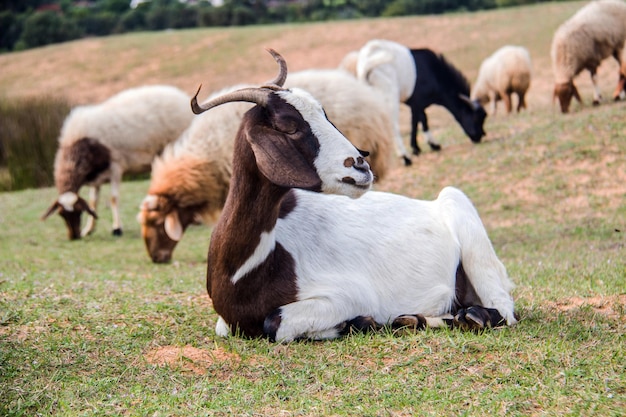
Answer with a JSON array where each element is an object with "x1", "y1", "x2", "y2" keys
[{"x1": 0, "y1": 0, "x2": 552, "y2": 52}]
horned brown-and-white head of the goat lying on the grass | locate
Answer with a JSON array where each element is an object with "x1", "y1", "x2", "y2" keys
[{"x1": 191, "y1": 50, "x2": 374, "y2": 198}]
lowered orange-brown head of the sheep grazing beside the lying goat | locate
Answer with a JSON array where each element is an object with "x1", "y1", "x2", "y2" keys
[{"x1": 137, "y1": 195, "x2": 199, "y2": 263}]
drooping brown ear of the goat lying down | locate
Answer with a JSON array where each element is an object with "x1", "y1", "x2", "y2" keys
[{"x1": 247, "y1": 126, "x2": 322, "y2": 191}]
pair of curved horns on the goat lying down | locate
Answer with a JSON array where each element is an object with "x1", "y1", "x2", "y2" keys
[{"x1": 191, "y1": 48, "x2": 287, "y2": 114}]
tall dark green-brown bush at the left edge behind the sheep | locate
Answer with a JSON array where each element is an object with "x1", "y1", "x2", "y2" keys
[{"x1": 0, "y1": 97, "x2": 71, "y2": 191}]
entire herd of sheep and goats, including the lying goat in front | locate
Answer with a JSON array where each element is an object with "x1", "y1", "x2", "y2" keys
[{"x1": 44, "y1": 0, "x2": 626, "y2": 341}]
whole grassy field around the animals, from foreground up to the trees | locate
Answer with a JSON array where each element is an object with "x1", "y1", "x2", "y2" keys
[{"x1": 0, "y1": 2, "x2": 626, "y2": 416}]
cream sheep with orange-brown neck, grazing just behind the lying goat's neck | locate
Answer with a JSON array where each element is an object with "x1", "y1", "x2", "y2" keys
[{"x1": 137, "y1": 89, "x2": 252, "y2": 263}]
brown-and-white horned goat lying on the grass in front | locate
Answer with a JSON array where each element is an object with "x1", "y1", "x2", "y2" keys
[{"x1": 192, "y1": 50, "x2": 516, "y2": 342}]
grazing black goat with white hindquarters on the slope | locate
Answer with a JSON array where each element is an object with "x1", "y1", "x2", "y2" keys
[{"x1": 356, "y1": 39, "x2": 487, "y2": 155}]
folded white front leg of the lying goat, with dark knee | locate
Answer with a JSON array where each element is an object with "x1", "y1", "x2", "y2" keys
[{"x1": 263, "y1": 299, "x2": 378, "y2": 343}]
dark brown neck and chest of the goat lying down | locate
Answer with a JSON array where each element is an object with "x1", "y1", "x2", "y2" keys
[{"x1": 207, "y1": 125, "x2": 296, "y2": 336}]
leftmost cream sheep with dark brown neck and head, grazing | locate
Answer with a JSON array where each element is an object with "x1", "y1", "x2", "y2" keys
[{"x1": 43, "y1": 85, "x2": 194, "y2": 239}]
